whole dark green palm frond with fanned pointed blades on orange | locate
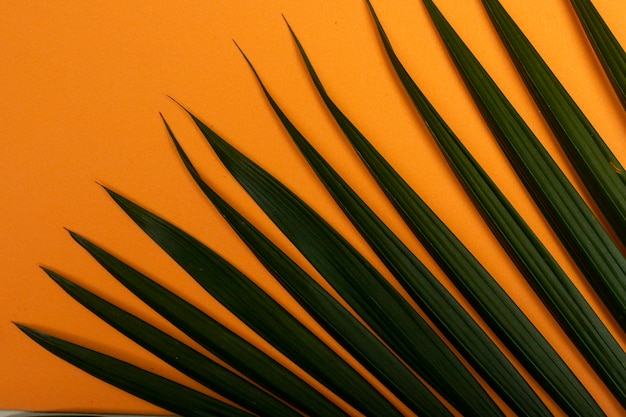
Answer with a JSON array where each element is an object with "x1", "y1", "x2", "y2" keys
[{"x1": 18, "y1": 0, "x2": 626, "y2": 417}]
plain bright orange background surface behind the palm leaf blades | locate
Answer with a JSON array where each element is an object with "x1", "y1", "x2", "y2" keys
[{"x1": 0, "y1": 0, "x2": 626, "y2": 415}]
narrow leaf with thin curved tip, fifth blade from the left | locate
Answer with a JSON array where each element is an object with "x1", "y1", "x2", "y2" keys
[{"x1": 164, "y1": 116, "x2": 449, "y2": 416}]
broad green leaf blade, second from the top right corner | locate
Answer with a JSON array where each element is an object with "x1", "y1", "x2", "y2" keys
[{"x1": 482, "y1": 0, "x2": 626, "y2": 247}]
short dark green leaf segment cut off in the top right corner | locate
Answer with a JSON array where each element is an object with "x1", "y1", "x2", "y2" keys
[{"x1": 570, "y1": 0, "x2": 626, "y2": 109}]
